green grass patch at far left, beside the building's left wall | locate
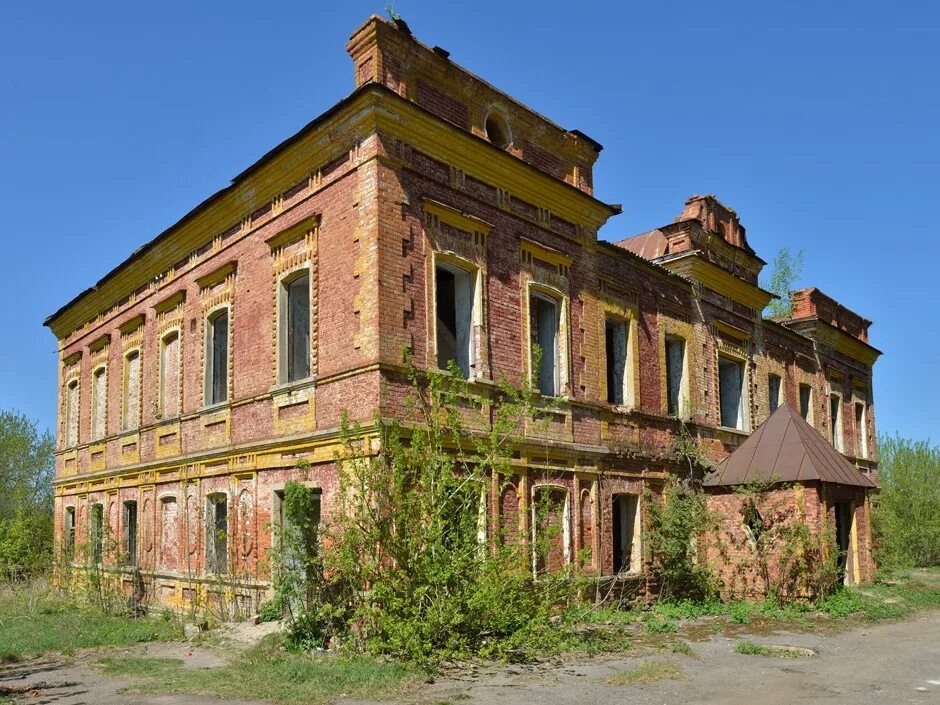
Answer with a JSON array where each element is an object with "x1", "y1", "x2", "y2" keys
[{"x1": 0, "y1": 586, "x2": 182, "y2": 663}]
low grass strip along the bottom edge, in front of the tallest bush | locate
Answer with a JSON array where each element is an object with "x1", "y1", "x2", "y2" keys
[{"x1": 98, "y1": 639, "x2": 422, "y2": 705}]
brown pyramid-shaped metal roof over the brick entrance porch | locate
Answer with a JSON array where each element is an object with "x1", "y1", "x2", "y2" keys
[{"x1": 704, "y1": 403, "x2": 878, "y2": 488}]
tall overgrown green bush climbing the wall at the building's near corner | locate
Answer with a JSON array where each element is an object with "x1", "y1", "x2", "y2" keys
[{"x1": 268, "y1": 360, "x2": 582, "y2": 664}]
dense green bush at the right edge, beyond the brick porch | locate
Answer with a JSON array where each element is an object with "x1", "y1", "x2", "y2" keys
[{"x1": 873, "y1": 436, "x2": 940, "y2": 568}]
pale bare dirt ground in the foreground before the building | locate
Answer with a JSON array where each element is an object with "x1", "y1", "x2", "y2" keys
[{"x1": 0, "y1": 612, "x2": 940, "y2": 705}]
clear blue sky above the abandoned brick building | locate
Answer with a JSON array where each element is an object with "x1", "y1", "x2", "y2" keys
[{"x1": 0, "y1": 0, "x2": 940, "y2": 440}]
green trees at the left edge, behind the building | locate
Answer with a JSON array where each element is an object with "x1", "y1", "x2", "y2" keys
[{"x1": 0, "y1": 411, "x2": 55, "y2": 579}]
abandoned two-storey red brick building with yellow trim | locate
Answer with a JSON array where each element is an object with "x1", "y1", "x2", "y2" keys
[{"x1": 46, "y1": 17, "x2": 879, "y2": 604}]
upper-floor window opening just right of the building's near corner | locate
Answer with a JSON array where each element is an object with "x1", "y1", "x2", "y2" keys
[{"x1": 434, "y1": 263, "x2": 475, "y2": 379}]
